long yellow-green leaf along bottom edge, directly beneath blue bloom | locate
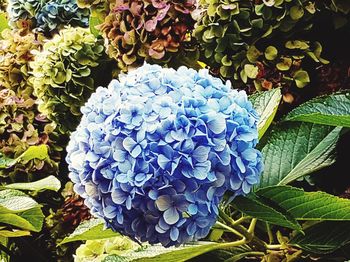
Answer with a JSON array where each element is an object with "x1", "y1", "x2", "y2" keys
[{"x1": 128, "y1": 242, "x2": 225, "y2": 262}]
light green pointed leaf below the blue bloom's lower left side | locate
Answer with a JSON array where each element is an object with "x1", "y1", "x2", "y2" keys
[{"x1": 58, "y1": 219, "x2": 119, "y2": 245}]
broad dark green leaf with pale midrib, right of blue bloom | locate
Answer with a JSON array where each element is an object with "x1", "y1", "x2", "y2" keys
[{"x1": 257, "y1": 122, "x2": 341, "y2": 187}]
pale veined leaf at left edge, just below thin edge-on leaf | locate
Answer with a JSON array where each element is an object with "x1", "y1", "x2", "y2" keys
[{"x1": 0, "y1": 189, "x2": 41, "y2": 214}]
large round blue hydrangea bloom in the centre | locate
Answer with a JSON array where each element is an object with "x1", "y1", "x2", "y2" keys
[{"x1": 67, "y1": 64, "x2": 263, "y2": 247}]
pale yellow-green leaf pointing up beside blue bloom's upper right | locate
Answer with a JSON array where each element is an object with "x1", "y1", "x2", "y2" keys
[{"x1": 249, "y1": 88, "x2": 282, "y2": 138}]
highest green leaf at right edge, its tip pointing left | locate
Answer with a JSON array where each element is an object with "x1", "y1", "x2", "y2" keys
[{"x1": 285, "y1": 91, "x2": 350, "y2": 127}]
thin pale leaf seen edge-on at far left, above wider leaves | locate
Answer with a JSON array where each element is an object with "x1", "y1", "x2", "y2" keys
[{"x1": 2, "y1": 176, "x2": 61, "y2": 192}]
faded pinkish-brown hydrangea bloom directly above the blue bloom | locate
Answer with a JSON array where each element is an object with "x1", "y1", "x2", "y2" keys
[{"x1": 98, "y1": 0, "x2": 197, "y2": 71}]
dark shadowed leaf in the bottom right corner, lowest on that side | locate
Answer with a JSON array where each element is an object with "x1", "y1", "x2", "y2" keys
[{"x1": 290, "y1": 221, "x2": 350, "y2": 254}]
